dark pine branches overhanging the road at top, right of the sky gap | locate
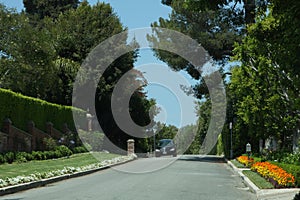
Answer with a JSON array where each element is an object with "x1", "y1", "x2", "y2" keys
[{"x1": 152, "y1": 0, "x2": 245, "y2": 65}]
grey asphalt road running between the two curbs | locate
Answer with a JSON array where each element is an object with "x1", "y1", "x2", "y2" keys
[{"x1": 0, "y1": 156, "x2": 256, "y2": 200}]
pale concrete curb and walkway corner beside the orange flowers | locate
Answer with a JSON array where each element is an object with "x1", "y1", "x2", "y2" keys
[{"x1": 226, "y1": 160, "x2": 300, "y2": 200}]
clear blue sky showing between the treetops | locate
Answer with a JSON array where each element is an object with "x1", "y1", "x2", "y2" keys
[{"x1": 0, "y1": 0, "x2": 197, "y2": 127}]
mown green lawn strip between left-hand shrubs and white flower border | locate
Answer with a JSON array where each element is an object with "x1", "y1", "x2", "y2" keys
[{"x1": 0, "y1": 152, "x2": 120, "y2": 179}]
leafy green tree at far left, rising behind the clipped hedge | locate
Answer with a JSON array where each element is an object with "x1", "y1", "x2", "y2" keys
[{"x1": 0, "y1": 5, "x2": 55, "y2": 98}]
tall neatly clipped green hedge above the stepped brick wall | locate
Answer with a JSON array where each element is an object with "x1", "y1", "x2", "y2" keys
[{"x1": 0, "y1": 89, "x2": 86, "y2": 131}]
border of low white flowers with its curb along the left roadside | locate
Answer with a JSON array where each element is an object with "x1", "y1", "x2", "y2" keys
[{"x1": 0, "y1": 154, "x2": 137, "y2": 196}]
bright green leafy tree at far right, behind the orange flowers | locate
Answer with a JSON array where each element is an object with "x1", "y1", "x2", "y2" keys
[{"x1": 229, "y1": 1, "x2": 300, "y2": 155}]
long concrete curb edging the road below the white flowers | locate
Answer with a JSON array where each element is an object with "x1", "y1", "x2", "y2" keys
[{"x1": 0, "y1": 156, "x2": 135, "y2": 196}]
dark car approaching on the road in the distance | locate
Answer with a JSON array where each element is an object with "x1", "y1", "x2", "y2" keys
[{"x1": 155, "y1": 139, "x2": 177, "y2": 157}]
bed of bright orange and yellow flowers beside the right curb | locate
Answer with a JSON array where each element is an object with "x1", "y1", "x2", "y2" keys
[{"x1": 251, "y1": 162, "x2": 295, "y2": 188}]
